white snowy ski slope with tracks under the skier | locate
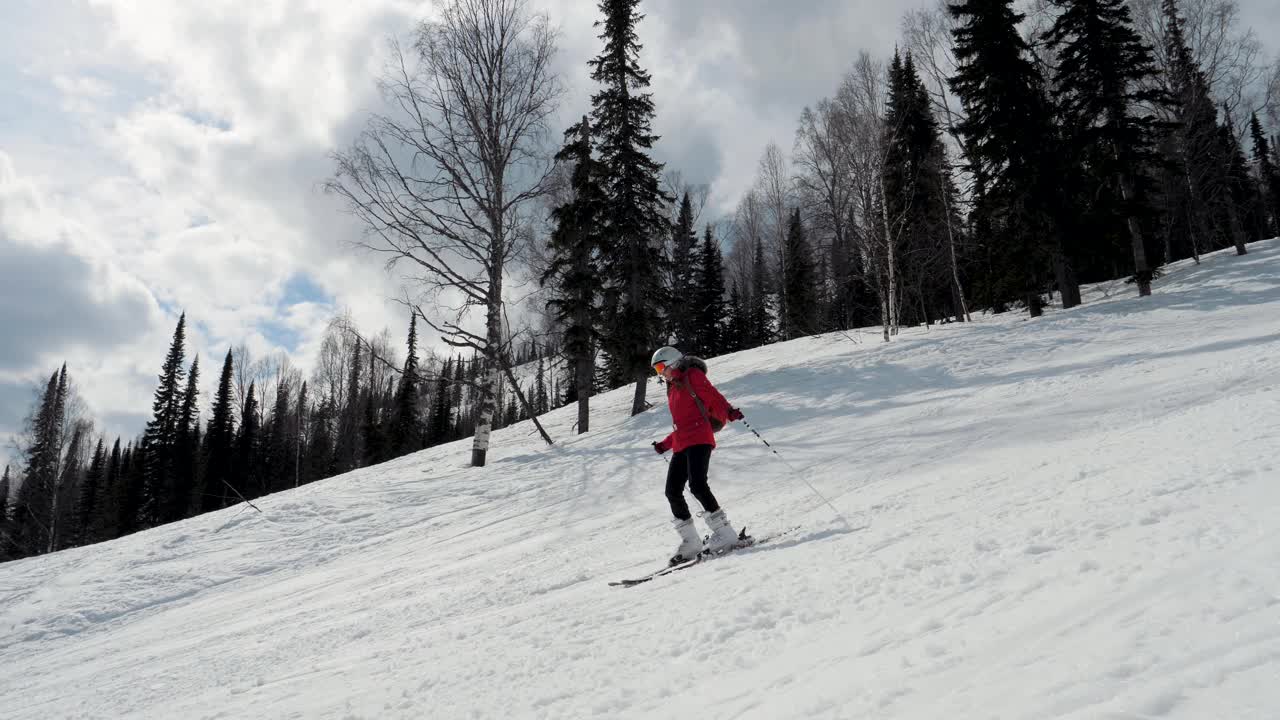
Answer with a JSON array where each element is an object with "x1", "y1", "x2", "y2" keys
[{"x1": 0, "y1": 241, "x2": 1280, "y2": 720}]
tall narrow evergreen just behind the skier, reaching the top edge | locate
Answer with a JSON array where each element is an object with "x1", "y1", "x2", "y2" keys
[{"x1": 590, "y1": 0, "x2": 671, "y2": 415}]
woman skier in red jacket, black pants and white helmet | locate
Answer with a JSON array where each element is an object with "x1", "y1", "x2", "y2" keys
[{"x1": 650, "y1": 347, "x2": 742, "y2": 565}]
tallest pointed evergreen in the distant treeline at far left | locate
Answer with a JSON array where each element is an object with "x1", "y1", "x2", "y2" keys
[{"x1": 141, "y1": 314, "x2": 187, "y2": 527}]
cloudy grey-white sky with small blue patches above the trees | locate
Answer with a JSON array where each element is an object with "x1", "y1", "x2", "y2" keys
[{"x1": 0, "y1": 0, "x2": 1280, "y2": 464}]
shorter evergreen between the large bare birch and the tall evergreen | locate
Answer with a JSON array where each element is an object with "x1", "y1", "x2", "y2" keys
[{"x1": 541, "y1": 117, "x2": 608, "y2": 433}]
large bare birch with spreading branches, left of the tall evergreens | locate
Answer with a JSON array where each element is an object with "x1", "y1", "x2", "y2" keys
[{"x1": 326, "y1": 0, "x2": 561, "y2": 466}]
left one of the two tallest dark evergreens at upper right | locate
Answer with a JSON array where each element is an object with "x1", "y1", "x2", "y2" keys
[{"x1": 948, "y1": 0, "x2": 1070, "y2": 316}]
